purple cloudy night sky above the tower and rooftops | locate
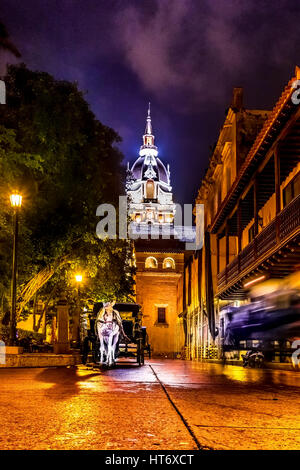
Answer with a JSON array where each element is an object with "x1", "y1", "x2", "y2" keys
[{"x1": 0, "y1": 0, "x2": 300, "y2": 203}]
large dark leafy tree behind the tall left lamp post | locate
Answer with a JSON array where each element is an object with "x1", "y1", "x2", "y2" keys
[{"x1": 0, "y1": 64, "x2": 133, "y2": 326}]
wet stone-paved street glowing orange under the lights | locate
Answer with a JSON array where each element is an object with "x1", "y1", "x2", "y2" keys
[{"x1": 0, "y1": 360, "x2": 300, "y2": 450}]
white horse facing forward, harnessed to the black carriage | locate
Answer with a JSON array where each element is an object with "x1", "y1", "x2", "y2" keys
[{"x1": 96, "y1": 302, "x2": 123, "y2": 366}]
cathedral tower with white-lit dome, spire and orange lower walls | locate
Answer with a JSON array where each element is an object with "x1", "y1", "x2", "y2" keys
[{"x1": 126, "y1": 106, "x2": 185, "y2": 357}]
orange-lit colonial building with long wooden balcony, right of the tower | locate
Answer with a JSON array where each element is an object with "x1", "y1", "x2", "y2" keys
[{"x1": 181, "y1": 74, "x2": 300, "y2": 358}]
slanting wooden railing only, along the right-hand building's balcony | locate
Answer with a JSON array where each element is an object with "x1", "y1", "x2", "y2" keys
[{"x1": 218, "y1": 195, "x2": 300, "y2": 291}]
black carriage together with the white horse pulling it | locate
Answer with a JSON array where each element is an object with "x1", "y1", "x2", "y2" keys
[{"x1": 82, "y1": 303, "x2": 150, "y2": 366}]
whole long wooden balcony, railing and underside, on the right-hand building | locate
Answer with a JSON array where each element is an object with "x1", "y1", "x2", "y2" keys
[{"x1": 217, "y1": 195, "x2": 300, "y2": 299}]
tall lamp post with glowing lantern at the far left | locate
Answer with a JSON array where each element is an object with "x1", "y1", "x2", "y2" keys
[{"x1": 9, "y1": 192, "x2": 22, "y2": 346}]
